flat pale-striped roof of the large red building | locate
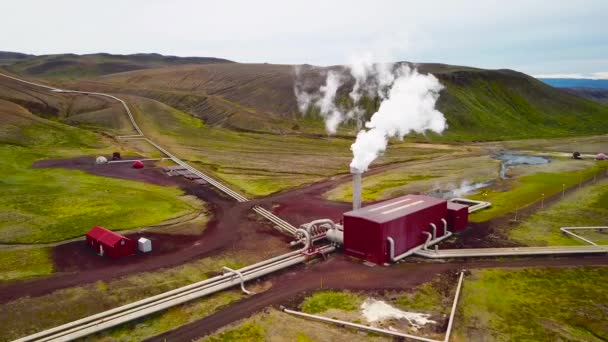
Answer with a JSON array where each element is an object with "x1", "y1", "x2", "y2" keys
[{"x1": 344, "y1": 195, "x2": 446, "y2": 223}]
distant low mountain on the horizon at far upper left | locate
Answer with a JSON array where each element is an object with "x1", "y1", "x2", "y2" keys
[{"x1": 0, "y1": 52, "x2": 233, "y2": 79}]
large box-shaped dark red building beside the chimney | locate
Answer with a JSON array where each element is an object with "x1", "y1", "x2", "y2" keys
[{"x1": 343, "y1": 195, "x2": 447, "y2": 264}]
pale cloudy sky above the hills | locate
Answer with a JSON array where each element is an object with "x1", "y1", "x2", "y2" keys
[{"x1": 0, "y1": 0, "x2": 608, "y2": 79}]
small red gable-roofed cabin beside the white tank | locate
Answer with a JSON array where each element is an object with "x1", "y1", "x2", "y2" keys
[{"x1": 87, "y1": 226, "x2": 136, "y2": 259}]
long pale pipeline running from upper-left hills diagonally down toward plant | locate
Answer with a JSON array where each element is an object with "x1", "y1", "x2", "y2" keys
[{"x1": 0, "y1": 72, "x2": 296, "y2": 236}]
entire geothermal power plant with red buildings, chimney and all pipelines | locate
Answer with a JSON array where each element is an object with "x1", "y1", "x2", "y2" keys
[{"x1": 6, "y1": 66, "x2": 608, "y2": 341}]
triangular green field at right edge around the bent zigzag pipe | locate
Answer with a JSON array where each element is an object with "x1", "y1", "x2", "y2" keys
[{"x1": 507, "y1": 180, "x2": 608, "y2": 246}]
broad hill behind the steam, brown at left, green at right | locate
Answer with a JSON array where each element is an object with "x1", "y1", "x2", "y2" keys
[{"x1": 7, "y1": 56, "x2": 608, "y2": 141}]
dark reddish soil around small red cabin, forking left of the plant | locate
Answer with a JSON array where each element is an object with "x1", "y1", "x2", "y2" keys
[{"x1": 0, "y1": 157, "x2": 304, "y2": 303}]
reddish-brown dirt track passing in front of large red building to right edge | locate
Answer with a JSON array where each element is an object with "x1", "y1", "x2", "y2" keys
[{"x1": 149, "y1": 254, "x2": 608, "y2": 341}]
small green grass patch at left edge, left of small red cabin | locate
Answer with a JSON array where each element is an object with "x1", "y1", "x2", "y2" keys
[{"x1": 0, "y1": 248, "x2": 54, "y2": 281}]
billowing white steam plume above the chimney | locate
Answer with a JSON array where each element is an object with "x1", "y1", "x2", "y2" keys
[{"x1": 294, "y1": 54, "x2": 447, "y2": 171}]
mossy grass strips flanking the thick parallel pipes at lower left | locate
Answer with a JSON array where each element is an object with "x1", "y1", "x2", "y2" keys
[{"x1": 0, "y1": 255, "x2": 247, "y2": 341}]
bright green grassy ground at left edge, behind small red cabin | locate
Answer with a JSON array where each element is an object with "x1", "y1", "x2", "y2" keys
[{"x1": 0, "y1": 100, "x2": 201, "y2": 243}]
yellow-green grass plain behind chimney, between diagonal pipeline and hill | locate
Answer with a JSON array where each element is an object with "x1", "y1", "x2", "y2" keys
[{"x1": 128, "y1": 96, "x2": 460, "y2": 196}]
